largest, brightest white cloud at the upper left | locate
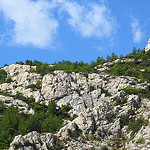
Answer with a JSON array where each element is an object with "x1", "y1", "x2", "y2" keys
[{"x1": 0, "y1": 0, "x2": 58, "y2": 48}]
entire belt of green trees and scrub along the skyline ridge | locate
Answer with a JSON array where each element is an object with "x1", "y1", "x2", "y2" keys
[{"x1": 9, "y1": 47, "x2": 150, "y2": 82}]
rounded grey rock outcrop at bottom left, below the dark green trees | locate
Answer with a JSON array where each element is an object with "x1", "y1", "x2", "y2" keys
[{"x1": 9, "y1": 131, "x2": 57, "y2": 150}]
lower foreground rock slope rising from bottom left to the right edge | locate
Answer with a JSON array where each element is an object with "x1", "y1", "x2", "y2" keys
[{"x1": 10, "y1": 92, "x2": 150, "y2": 150}]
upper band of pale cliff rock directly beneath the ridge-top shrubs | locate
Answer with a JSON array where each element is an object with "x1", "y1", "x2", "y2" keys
[{"x1": 0, "y1": 64, "x2": 150, "y2": 114}]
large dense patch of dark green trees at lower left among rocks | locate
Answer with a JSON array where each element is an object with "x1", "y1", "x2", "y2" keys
[{"x1": 0, "y1": 101, "x2": 71, "y2": 149}]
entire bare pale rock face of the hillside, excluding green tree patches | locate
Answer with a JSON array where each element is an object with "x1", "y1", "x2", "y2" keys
[{"x1": 0, "y1": 63, "x2": 150, "y2": 150}]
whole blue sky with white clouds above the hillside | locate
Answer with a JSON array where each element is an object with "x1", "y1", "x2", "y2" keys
[{"x1": 0, "y1": 0, "x2": 150, "y2": 66}]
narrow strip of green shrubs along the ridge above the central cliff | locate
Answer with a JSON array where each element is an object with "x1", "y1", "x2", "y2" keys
[{"x1": 16, "y1": 57, "x2": 106, "y2": 75}]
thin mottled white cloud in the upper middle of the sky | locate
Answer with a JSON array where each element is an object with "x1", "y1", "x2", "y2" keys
[{"x1": 59, "y1": 0, "x2": 116, "y2": 38}]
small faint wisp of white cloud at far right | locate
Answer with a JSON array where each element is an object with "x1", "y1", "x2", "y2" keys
[{"x1": 131, "y1": 17, "x2": 144, "y2": 43}]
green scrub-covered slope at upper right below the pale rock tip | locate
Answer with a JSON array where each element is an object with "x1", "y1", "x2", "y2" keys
[{"x1": 106, "y1": 47, "x2": 150, "y2": 82}]
